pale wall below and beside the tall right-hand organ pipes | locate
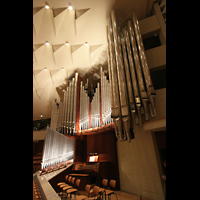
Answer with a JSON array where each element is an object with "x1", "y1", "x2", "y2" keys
[{"x1": 117, "y1": 88, "x2": 166, "y2": 200}]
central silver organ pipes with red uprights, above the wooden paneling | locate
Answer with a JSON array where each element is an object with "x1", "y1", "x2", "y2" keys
[{"x1": 50, "y1": 71, "x2": 113, "y2": 136}]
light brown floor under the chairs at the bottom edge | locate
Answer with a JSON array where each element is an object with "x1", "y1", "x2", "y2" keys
[{"x1": 59, "y1": 191, "x2": 150, "y2": 200}]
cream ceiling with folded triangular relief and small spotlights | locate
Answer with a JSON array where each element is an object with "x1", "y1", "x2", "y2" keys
[{"x1": 33, "y1": 0, "x2": 154, "y2": 120}]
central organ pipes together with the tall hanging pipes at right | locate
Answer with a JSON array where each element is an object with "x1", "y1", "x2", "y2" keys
[{"x1": 45, "y1": 10, "x2": 156, "y2": 150}]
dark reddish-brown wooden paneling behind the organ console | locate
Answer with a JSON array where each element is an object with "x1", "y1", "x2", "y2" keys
[{"x1": 75, "y1": 129, "x2": 120, "y2": 190}]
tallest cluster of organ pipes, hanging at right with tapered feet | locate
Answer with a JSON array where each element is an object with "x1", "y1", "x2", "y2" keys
[{"x1": 107, "y1": 10, "x2": 156, "y2": 142}]
